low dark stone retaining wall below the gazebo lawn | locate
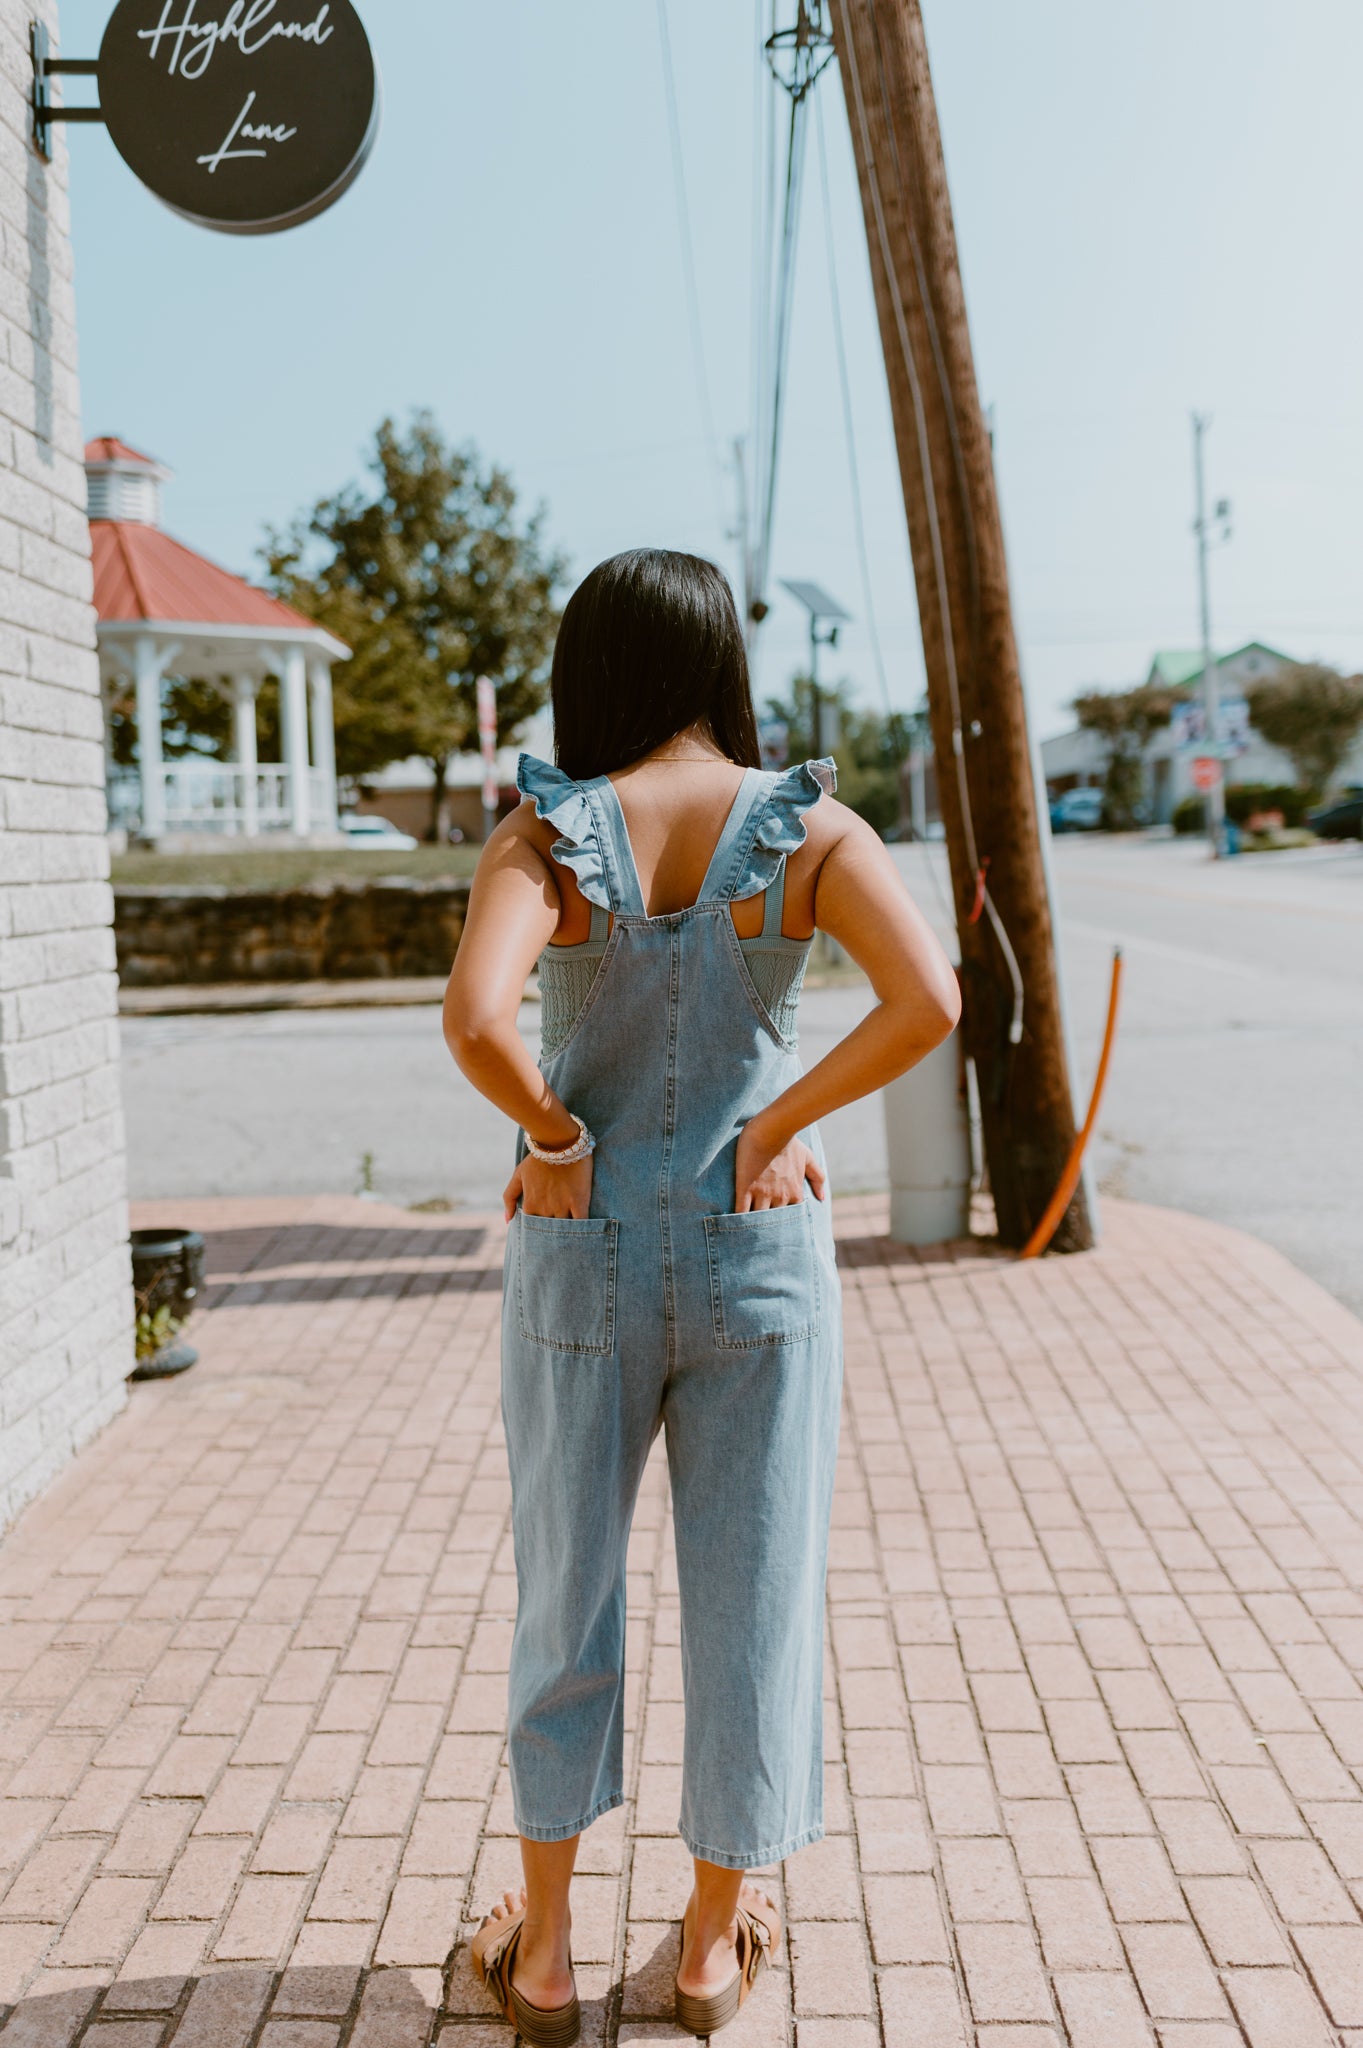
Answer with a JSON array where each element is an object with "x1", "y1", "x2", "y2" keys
[{"x1": 115, "y1": 879, "x2": 469, "y2": 989}]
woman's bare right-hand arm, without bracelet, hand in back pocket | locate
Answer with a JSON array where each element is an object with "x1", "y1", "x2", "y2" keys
[{"x1": 735, "y1": 799, "x2": 960, "y2": 1208}]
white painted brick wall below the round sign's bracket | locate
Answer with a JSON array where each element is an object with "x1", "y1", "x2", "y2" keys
[{"x1": 0, "y1": 0, "x2": 131, "y2": 1526}]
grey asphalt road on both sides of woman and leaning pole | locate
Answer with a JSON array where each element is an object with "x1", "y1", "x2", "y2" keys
[{"x1": 123, "y1": 836, "x2": 1363, "y2": 1313}]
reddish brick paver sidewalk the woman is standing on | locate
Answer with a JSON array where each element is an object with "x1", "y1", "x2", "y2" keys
[{"x1": 0, "y1": 1200, "x2": 1363, "y2": 2048}]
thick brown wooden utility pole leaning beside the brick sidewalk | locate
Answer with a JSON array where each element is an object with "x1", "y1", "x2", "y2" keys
[{"x1": 833, "y1": 0, "x2": 1093, "y2": 1251}]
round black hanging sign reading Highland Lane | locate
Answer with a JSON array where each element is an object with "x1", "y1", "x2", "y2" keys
[{"x1": 100, "y1": 0, "x2": 379, "y2": 236}]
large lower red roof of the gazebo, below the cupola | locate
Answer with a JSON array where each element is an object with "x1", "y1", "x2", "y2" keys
[{"x1": 90, "y1": 518, "x2": 317, "y2": 633}]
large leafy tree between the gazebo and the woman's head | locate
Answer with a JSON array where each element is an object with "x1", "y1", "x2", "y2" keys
[{"x1": 262, "y1": 412, "x2": 565, "y2": 838}]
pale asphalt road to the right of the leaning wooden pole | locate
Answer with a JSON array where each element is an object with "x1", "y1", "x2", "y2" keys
[{"x1": 1035, "y1": 838, "x2": 1363, "y2": 1313}]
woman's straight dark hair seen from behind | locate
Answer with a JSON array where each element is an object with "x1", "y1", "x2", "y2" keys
[{"x1": 553, "y1": 547, "x2": 761, "y2": 782}]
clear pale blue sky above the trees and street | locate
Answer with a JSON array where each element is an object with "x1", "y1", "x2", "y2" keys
[{"x1": 61, "y1": 0, "x2": 1363, "y2": 733}]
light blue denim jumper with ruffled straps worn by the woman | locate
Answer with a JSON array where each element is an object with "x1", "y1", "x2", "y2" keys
[{"x1": 501, "y1": 756, "x2": 841, "y2": 1870}]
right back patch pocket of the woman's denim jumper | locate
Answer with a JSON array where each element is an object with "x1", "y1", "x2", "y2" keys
[{"x1": 706, "y1": 1202, "x2": 819, "y2": 1352}]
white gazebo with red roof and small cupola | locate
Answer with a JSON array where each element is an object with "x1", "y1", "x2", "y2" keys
[{"x1": 86, "y1": 434, "x2": 350, "y2": 844}]
